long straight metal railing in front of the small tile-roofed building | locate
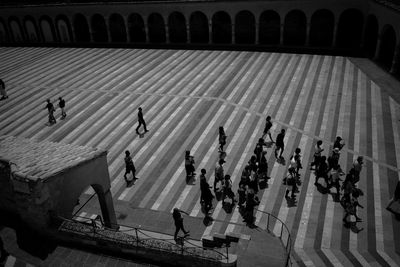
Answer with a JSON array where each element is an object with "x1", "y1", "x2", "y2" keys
[{"x1": 58, "y1": 215, "x2": 229, "y2": 262}]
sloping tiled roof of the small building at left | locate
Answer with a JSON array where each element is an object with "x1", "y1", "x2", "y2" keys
[{"x1": 0, "y1": 136, "x2": 107, "y2": 180}]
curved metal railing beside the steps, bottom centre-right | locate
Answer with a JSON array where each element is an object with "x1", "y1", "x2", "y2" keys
[{"x1": 255, "y1": 209, "x2": 292, "y2": 266}]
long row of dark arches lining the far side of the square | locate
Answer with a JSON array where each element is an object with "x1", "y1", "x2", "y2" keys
[{"x1": 0, "y1": 8, "x2": 400, "y2": 73}]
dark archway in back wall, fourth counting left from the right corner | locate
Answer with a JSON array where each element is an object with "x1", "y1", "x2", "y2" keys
[{"x1": 258, "y1": 10, "x2": 281, "y2": 45}]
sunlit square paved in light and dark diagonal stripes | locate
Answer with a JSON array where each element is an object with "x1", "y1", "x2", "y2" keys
[{"x1": 0, "y1": 48, "x2": 400, "y2": 266}]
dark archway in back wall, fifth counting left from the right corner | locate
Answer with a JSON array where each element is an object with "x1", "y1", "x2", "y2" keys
[{"x1": 235, "y1": 10, "x2": 256, "y2": 44}]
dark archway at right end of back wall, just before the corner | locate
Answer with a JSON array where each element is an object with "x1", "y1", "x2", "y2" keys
[{"x1": 337, "y1": 9, "x2": 364, "y2": 49}]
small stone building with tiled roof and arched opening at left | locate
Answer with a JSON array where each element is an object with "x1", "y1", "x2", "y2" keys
[{"x1": 0, "y1": 136, "x2": 117, "y2": 231}]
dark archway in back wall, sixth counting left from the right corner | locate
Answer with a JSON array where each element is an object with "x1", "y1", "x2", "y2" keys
[{"x1": 212, "y1": 11, "x2": 232, "y2": 44}]
